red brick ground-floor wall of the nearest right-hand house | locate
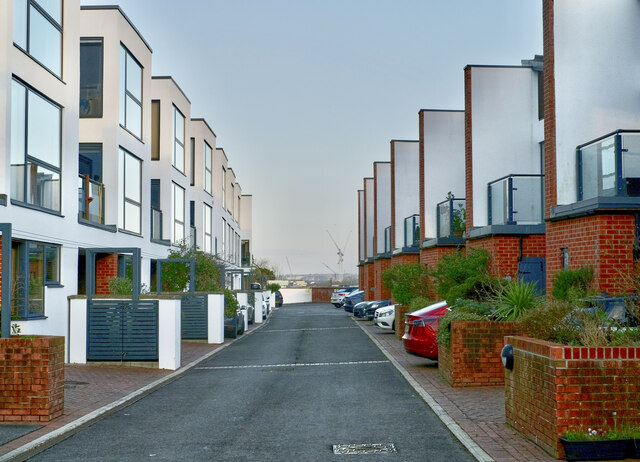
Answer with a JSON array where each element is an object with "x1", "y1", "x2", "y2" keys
[{"x1": 546, "y1": 214, "x2": 635, "y2": 294}]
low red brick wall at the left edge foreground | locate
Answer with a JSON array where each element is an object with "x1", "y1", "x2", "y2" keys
[{"x1": 0, "y1": 337, "x2": 64, "y2": 422}]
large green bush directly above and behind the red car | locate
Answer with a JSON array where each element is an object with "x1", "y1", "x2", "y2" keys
[{"x1": 433, "y1": 249, "x2": 499, "y2": 303}]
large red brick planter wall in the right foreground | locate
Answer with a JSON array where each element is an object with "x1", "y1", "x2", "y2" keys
[{"x1": 505, "y1": 337, "x2": 640, "y2": 458}]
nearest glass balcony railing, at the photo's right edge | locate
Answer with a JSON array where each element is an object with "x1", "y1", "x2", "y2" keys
[{"x1": 576, "y1": 130, "x2": 640, "y2": 200}]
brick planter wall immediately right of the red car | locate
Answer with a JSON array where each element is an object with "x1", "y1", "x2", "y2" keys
[{"x1": 438, "y1": 321, "x2": 516, "y2": 387}]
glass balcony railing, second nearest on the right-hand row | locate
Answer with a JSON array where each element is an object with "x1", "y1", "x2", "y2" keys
[{"x1": 489, "y1": 175, "x2": 543, "y2": 225}]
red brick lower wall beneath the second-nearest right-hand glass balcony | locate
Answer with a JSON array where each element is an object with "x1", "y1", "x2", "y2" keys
[{"x1": 467, "y1": 234, "x2": 546, "y2": 278}]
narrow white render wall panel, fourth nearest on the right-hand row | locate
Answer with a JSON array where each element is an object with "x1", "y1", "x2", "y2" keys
[{"x1": 391, "y1": 141, "x2": 420, "y2": 249}]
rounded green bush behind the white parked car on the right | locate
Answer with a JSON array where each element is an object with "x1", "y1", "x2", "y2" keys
[{"x1": 382, "y1": 263, "x2": 429, "y2": 305}]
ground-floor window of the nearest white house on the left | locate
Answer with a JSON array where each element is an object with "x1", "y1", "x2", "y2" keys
[{"x1": 11, "y1": 240, "x2": 60, "y2": 319}]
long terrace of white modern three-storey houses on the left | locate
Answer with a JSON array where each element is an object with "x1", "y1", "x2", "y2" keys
[{"x1": 0, "y1": 0, "x2": 252, "y2": 342}]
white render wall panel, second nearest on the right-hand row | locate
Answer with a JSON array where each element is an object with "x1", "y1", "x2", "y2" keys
[{"x1": 471, "y1": 67, "x2": 540, "y2": 227}]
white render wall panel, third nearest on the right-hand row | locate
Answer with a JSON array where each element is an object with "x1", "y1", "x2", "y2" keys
[{"x1": 423, "y1": 111, "x2": 465, "y2": 238}]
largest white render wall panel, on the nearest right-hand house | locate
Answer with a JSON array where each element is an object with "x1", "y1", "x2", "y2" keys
[{"x1": 551, "y1": 0, "x2": 640, "y2": 205}]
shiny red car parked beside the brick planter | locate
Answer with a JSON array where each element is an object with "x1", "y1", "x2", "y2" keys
[{"x1": 402, "y1": 301, "x2": 449, "y2": 361}]
